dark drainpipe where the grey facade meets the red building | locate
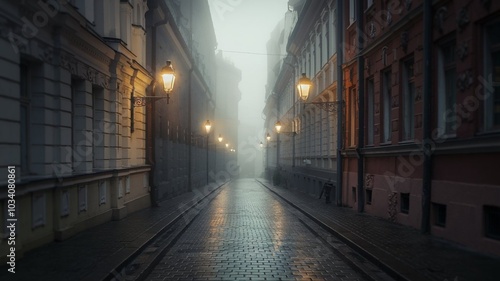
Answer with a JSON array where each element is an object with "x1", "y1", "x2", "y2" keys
[{"x1": 335, "y1": 1, "x2": 344, "y2": 206}]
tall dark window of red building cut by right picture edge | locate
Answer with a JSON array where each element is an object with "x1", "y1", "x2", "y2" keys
[{"x1": 484, "y1": 22, "x2": 500, "y2": 131}]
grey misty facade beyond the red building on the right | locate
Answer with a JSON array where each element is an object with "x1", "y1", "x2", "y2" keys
[{"x1": 264, "y1": 1, "x2": 337, "y2": 200}]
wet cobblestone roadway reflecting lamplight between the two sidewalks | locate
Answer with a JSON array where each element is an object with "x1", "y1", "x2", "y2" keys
[{"x1": 146, "y1": 179, "x2": 389, "y2": 281}]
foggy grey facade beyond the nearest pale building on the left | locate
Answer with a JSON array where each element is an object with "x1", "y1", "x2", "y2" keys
[{"x1": 145, "y1": 0, "x2": 220, "y2": 202}]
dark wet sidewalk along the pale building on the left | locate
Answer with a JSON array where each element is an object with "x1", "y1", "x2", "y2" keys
[{"x1": 0, "y1": 182, "x2": 227, "y2": 281}]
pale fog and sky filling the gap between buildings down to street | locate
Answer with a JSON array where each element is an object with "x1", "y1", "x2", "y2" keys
[{"x1": 209, "y1": 0, "x2": 288, "y2": 177}]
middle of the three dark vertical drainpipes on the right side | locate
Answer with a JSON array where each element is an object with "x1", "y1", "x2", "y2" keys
[{"x1": 356, "y1": 0, "x2": 365, "y2": 210}]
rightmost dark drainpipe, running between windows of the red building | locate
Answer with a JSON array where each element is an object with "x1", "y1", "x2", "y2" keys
[{"x1": 420, "y1": 0, "x2": 432, "y2": 233}]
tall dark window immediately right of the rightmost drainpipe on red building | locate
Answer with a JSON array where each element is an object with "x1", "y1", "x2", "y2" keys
[{"x1": 438, "y1": 40, "x2": 457, "y2": 135}]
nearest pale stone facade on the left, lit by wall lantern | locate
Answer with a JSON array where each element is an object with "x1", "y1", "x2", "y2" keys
[{"x1": 0, "y1": 1, "x2": 152, "y2": 257}]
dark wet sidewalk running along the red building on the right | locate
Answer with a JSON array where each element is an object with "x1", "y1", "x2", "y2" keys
[{"x1": 257, "y1": 179, "x2": 500, "y2": 281}]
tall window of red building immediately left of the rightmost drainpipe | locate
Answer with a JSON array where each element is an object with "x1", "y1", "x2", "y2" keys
[{"x1": 400, "y1": 58, "x2": 415, "y2": 140}]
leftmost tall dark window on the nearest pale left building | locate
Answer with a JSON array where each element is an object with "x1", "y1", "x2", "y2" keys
[{"x1": 19, "y1": 62, "x2": 31, "y2": 174}]
